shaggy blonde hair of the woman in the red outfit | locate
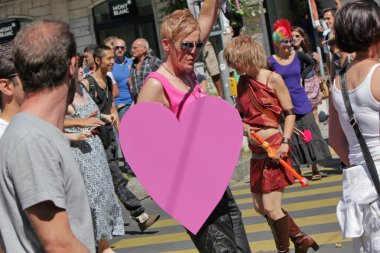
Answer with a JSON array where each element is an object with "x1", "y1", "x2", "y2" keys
[{"x1": 224, "y1": 34, "x2": 268, "y2": 72}]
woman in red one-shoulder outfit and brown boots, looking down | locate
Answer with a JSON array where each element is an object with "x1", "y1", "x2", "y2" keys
[{"x1": 224, "y1": 35, "x2": 318, "y2": 253}]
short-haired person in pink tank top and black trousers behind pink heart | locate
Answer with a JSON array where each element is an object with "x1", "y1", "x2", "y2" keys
[{"x1": 137, "y1": 0, "x2": 251, "y2": 252}]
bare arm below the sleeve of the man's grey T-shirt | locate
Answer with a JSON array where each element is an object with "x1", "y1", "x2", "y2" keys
[{"x1": 25, "y1": 201, "x2": 90, "y2": 253}]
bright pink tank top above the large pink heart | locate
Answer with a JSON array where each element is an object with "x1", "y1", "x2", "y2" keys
[{"x1": 145, "y1": 72, "x2": 207, "y2": 119}]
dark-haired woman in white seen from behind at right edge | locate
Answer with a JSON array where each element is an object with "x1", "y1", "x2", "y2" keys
[{"x1": 330, "y1": 0, "x2": 380, "y2": 253}]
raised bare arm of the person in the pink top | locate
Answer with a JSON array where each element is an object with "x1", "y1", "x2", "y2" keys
[{"x1": 198, "y1": 0, "x2": 221, "y2": 43}]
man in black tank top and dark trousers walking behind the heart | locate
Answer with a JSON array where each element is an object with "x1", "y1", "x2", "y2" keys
[{"x1": 82, "y1": 46, "x2": 160, "y2": 231}]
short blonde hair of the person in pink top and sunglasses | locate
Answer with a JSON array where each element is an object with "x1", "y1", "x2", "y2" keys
[{"x1": 160, "y1": 9, "x2": 201, "y2": 43}]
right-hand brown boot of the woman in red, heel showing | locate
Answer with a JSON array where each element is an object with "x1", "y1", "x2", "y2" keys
[{"x1": 282, "y1": 210, "x2": 319, "y2": 253}]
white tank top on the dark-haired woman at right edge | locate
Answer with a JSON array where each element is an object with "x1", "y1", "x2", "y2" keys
[{"x1": 332, "y1": 64, "x2": 380, "y2": 165}]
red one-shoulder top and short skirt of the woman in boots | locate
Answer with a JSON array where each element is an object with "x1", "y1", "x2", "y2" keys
[{"x1": 236, "y1": 75, "x2": 294, "y2": 194}]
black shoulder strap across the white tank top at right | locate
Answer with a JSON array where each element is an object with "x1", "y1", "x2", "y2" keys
[{"x1": 340, "y1": 71, "x2": 380, "y2": 196}]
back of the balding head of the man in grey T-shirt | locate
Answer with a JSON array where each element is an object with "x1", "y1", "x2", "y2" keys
[{"x1": 13, "y1": 20, "x2": 76, "y2": 93}]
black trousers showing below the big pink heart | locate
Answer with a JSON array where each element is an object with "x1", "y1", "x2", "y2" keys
[{"x1": 187, "y1": 187, "x2": 251, "y2": 253}]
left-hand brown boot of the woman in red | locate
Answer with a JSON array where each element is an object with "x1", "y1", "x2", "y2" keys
[{"x1": 265, "y1": 215, "x2": 289, "y2": 253}]
